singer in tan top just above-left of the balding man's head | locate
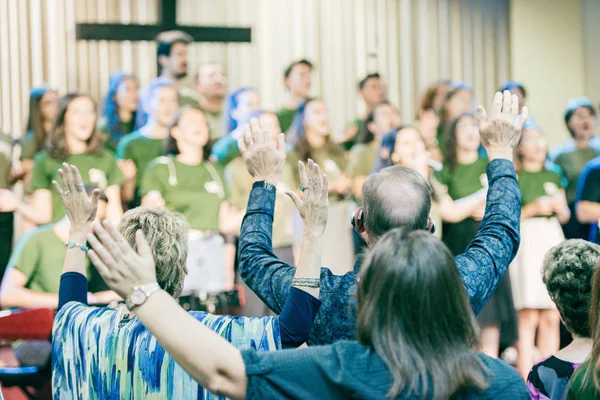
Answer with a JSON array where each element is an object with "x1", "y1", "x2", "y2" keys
[{"x1": 346, "y1": 102, "x2": 400, "y2": 203}]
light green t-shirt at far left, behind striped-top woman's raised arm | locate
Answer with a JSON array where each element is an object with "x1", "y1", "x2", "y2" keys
[{"x1": 7, "y1": 224, "x2": 108, "y2": 294}]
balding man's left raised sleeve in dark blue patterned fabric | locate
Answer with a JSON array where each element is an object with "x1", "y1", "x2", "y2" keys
[{"x1": 238, "y1": 182, "x2": 296, "y2": 314}]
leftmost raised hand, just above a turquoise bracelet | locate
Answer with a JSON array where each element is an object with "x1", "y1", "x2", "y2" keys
[{"x1": 52, "y1": 163, "x2": 100, "y2": 232}]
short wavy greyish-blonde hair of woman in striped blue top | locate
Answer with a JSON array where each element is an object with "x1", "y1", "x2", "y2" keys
[{"x1": 119, "y1": 207, "x2": 189, "y2": 298}]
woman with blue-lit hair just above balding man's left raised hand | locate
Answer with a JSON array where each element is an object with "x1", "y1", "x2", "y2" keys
[{"x1": 210, "y1": 86, "x2": 258, "y2": 165}]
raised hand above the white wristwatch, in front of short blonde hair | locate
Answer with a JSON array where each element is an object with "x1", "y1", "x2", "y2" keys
[{"x1": 87, "y1": 221, "x2": 156, "y2": 299}]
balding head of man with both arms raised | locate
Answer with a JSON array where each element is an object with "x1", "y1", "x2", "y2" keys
[{"x1": 362, "y1": 165, "x2": 432, "y2": 242}]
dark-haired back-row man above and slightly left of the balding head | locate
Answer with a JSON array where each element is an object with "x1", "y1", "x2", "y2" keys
[{"x1": 341, "y1": 72, "x2": 389, "y2": 151}]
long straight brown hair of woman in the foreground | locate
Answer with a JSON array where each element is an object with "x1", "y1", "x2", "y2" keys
[{"x1": 357, "y1": 229, "x2": 487, "y2": 398}]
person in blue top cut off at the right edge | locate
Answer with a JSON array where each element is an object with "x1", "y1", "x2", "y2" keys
[{"x1": 575, "y1": 156, "x2": 600, "y2": 243}]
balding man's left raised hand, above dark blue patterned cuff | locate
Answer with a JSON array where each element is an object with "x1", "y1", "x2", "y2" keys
[{"x1": 238, "y1": 118, "x2": 285, "y2": 185}]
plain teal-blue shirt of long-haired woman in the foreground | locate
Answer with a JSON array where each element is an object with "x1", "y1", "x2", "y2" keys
[{"x1": 242, "y1": 341, "x2": 529, "y2": 400}]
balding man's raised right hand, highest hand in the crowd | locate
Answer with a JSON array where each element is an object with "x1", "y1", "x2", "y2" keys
[{"x1": 476, "y1": 90, "x2": 529, "y2": 161}]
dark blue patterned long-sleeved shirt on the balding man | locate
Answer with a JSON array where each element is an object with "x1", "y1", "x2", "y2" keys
[{"x1": 239, "y1": 160, "x2": 521, "y2": 344}]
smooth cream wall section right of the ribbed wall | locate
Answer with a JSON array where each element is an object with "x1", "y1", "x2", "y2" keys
[{"x1": 510, "y1": 0, "x2": 584, "y2": 146}]
